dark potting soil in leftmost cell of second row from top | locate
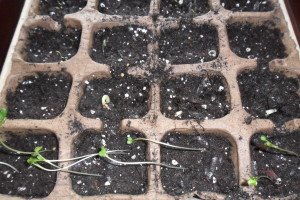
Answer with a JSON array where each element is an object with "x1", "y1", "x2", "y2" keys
[{"x1": 23, "y1": 27, "x2": 81, "y2": 63}]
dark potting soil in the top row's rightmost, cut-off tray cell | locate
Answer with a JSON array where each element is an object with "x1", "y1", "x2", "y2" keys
[{"x1": 221, "y1": 0, "x2": 273, "y2": 12}]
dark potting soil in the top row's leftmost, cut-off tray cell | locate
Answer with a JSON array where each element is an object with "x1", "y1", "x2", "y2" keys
[{"x1": 39, "y1": 0, "x2": 87, "y2": 22}]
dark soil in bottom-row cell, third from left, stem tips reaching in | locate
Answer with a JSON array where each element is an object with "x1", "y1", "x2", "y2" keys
[{"x1": 161, "y1": 132, "x2": 238, "y2": 195}]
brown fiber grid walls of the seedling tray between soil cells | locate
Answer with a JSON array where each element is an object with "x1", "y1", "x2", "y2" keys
[{"x1": 0, "y1": 0, "x2": 300, "y2": 200}]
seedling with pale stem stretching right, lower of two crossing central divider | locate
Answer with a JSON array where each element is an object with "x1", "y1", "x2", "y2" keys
[{"x1": 98, "y1": 146, "x2": 186, "y2": 169}]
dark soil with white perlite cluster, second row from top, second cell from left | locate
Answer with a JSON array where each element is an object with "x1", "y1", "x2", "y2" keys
[{"x1": 91, "y1": 25, "x2": 153, "y2": 68}]
